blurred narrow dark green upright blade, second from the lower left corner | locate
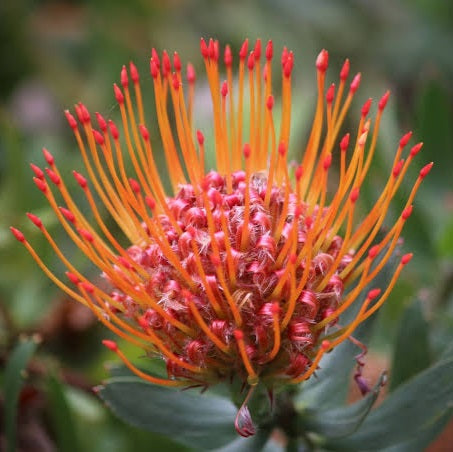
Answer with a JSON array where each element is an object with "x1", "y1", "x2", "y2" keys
[{"x1": 47, "y1": 377, "x2": 80, "y2": 452}]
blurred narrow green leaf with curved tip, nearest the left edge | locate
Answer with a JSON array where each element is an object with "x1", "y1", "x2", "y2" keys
[{"x1": 4, "y1": 338, "x2": 38, "y2": 452}]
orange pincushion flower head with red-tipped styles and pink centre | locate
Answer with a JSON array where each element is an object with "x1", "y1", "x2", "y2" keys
[{"x1": 12, "y1": 40, "x2": 432, "y2": 435}]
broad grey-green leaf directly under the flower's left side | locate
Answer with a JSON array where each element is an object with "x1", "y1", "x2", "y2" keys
[{"x1": 99, "y1": 377, "x2": 237, "y2": 450}]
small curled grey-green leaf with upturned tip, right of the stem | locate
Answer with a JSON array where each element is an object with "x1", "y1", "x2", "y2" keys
[{"x1": 301, "y1": 373, "x2": 387, "y2": 438}]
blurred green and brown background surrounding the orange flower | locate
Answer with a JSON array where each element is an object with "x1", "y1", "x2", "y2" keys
[{"x1": 0, "y1": 0, "x2": 453, "y2": 452}]
